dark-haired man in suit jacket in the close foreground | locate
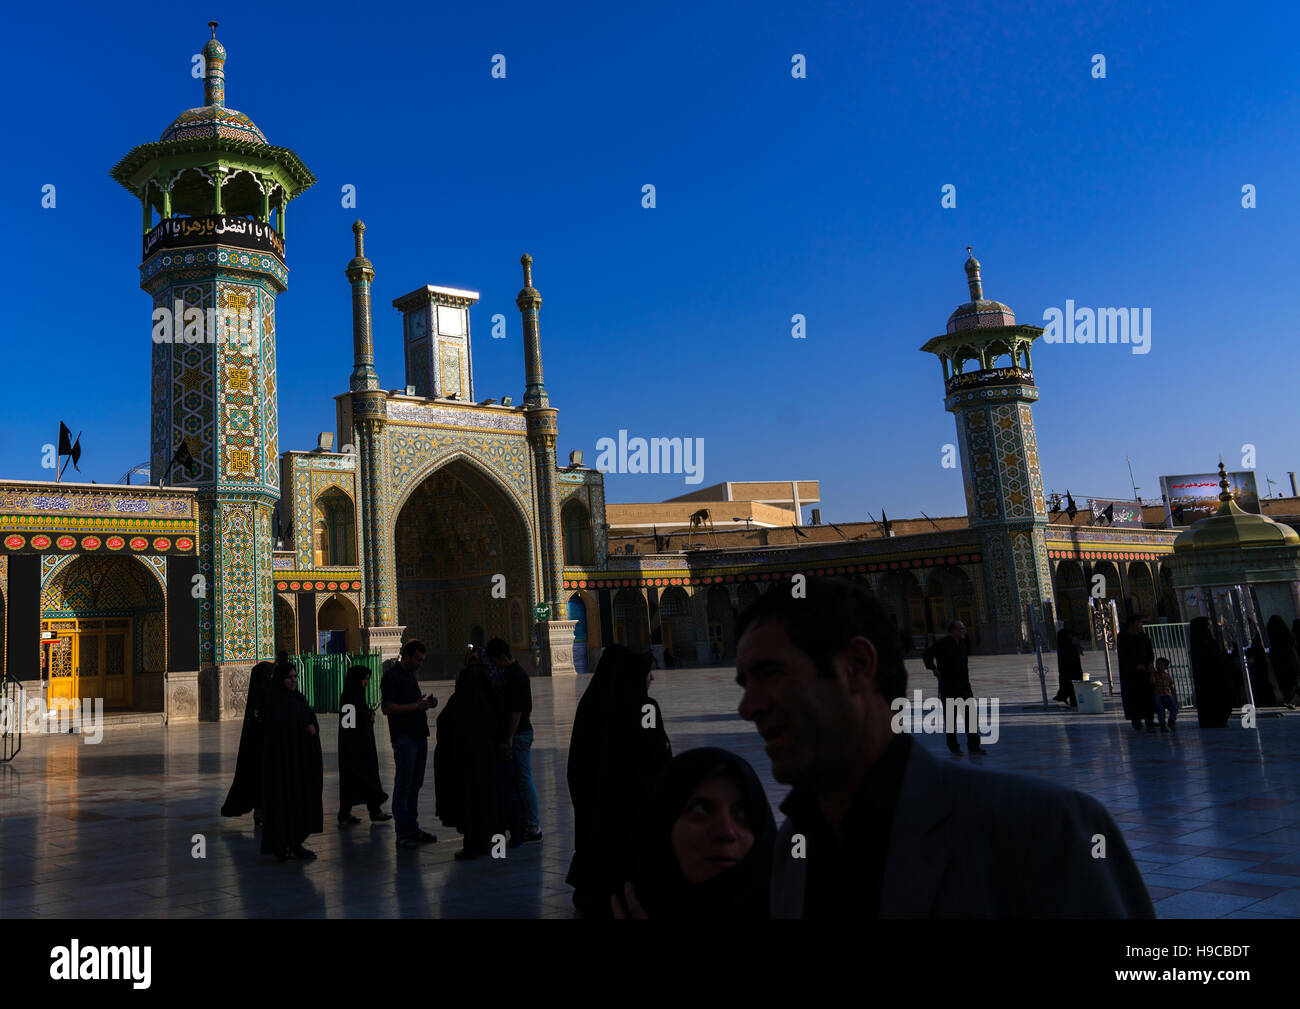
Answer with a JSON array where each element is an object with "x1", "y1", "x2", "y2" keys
[{"x1": 736, "y1": 579, "x2": 1154, "y2": 918}]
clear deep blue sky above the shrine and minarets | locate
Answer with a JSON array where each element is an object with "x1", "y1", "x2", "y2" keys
[{"x1": 0, "y1": 0, "x2": 1300, "y2": 520}]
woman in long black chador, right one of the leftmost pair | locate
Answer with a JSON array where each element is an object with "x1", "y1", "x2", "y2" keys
[{"x1": 261, "y1": 662, "x2": 325, "y2": 861}]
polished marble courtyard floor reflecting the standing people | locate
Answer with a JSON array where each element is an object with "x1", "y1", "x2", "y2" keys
[{"x1": 0, "y1": 655, "x2": 1300, "y2": 918}]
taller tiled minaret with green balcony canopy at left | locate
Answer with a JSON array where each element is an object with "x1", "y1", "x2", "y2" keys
[{"x1": 112, "y1": 22, "x2": 316, "y2": 719}]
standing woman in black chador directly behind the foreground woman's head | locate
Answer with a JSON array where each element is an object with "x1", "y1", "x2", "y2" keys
[{"x1": 564, "y1": 645, "x2": 672, "y2": 918}]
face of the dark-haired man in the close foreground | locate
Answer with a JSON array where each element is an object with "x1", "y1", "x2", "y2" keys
[{"x1": 736, "y1": 620, "x2": 888, "y2": 785}]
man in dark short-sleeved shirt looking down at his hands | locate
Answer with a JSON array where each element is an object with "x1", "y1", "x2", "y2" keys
[{"x1": 380, "y1": 640, "x2": 438, "y2": 848}]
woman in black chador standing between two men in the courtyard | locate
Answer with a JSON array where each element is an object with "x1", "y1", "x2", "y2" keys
[{"x1": 433, "y1": 649, "x2": 503, "y2": 859}]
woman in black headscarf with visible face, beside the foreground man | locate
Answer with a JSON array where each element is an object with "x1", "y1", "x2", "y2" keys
[{"x1": 612, "y1": 746, "x2": 776, "y2": 922}]
